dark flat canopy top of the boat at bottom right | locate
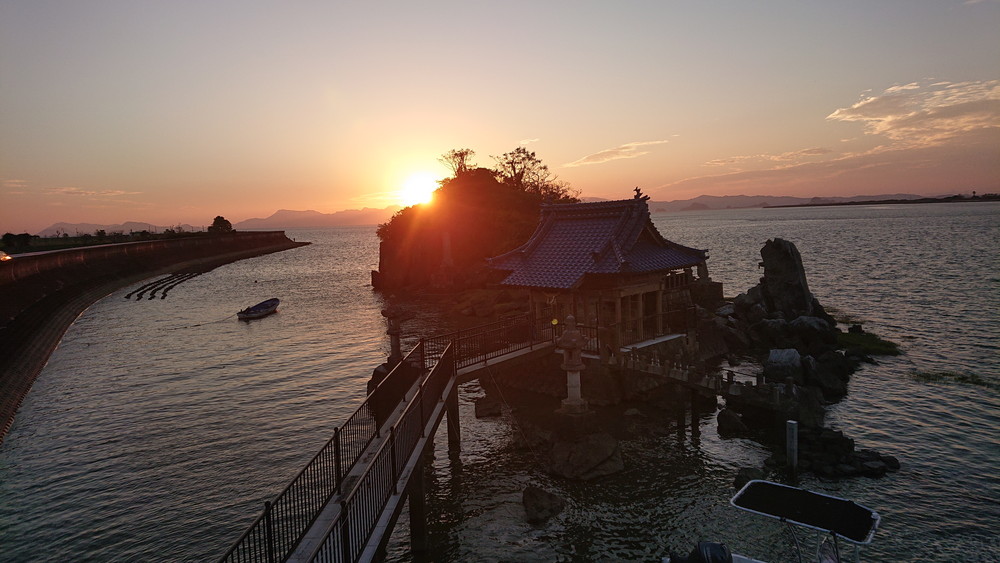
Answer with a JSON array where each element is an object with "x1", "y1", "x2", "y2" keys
[{"x1": 731, "y1": 480, "x2": 879, "y2": 544}]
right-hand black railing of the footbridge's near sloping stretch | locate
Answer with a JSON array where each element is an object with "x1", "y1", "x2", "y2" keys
[{"x1": 310, "y1": 345, "x2": 457, "y2": 563}]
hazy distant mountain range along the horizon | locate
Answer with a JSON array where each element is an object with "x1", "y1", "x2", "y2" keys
[{"x1": 37, "y1": 194, "x2": 940, "y2": 237}]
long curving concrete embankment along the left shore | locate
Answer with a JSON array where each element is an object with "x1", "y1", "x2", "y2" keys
[{"x1": 0, "y1": 231, "x2": 309, "y2": 442}]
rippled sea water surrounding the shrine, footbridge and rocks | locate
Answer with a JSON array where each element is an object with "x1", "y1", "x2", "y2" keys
[{"x1": 0, "y1": 204, "x2": 1000, "y2": 561}]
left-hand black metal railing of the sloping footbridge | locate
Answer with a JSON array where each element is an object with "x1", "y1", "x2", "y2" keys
[{"x1": 220, "y1": 344, "x2": 424, "y2": 563}]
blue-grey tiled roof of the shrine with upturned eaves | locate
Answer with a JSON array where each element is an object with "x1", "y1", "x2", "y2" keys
[{"x1": 489, "y1": 198, "x2": 706, "y2": 289}]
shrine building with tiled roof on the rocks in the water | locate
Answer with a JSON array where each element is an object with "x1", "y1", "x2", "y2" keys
[{"x1": 489, "y1": 189, "x2": 722, "y2": 352}]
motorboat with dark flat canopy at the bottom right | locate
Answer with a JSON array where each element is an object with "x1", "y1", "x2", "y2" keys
[{"x1": 663, "y1": 480, "x2": 880, "y2": 563}]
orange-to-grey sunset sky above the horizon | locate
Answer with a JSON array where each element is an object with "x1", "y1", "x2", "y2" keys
[{"x1": 0, "y1": 0, "x2": 1000, "y2": 232}]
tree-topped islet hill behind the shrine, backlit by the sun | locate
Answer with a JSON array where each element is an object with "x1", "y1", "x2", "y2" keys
[{"x1": 372, "y1": 147, "x2": 578, "y2": 289}]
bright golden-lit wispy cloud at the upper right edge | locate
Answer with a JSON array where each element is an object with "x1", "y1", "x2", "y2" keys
[{"x1": 827, "y1": 80, "x2": 1000, "y2": 148}]
